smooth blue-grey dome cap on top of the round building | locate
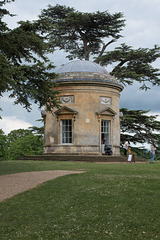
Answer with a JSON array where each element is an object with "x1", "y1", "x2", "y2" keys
[{"x1": 57, "y1": 60, "x2": 108, "y2": 74}]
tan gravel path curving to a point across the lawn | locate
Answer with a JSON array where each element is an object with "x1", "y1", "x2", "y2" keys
[{"x1": 0, "y1": 170, "x2": 84, "y2": 202}]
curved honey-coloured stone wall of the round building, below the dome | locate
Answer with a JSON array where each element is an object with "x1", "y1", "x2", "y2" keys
[{"x1": 44, "y1": 81, "x2": 120, "y2": 155}]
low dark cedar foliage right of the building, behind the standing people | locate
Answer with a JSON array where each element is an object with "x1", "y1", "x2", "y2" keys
[{"x1": 120, "y1": 108, "x2": 160, "y2": 159}]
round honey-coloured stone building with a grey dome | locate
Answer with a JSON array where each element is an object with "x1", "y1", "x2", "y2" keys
[{"x1": 44, "y1": 60, "x2": 123, "y2": 155}]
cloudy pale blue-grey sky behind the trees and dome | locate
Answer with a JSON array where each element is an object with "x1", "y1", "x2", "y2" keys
[{"x1": 0, "y1": 0, "x2": 160, "y2": 134}]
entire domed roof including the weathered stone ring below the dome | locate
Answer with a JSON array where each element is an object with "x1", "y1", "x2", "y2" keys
[{"x1": 54, "y1": 60, "x2": 123, "y2": 91}]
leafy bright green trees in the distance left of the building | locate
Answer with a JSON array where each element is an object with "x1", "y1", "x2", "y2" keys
[{"x1": 0, "y1": 127, "x2": 43, "y2": 160}]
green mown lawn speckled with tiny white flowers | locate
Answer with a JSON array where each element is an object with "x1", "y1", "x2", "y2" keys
[{"x1": 0, "y1": 161, "x2": 160, "y2": 240}]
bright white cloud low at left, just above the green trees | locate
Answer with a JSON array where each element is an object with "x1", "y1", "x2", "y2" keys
[{"x1": 0, "y1": 116, "x2": 32, "y2": 135}]
